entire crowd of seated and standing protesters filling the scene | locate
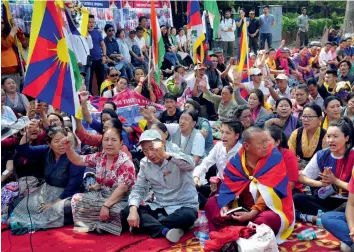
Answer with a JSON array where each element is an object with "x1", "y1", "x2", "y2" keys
[{"x1": 1, "y1": 6, "x2": 354, "y2": 251}]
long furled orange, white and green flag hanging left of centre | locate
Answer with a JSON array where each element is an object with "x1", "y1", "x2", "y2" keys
[{"x1": 150, "y1": 1, "x2": 165, "y2": 84}]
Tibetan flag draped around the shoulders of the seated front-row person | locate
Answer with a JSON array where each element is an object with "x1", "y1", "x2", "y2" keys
[{"x1": 217, "y1": 146, "x2": 295, "y2": 244}]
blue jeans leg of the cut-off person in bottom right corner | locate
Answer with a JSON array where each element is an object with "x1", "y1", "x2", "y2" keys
[{"x1": 321, "y1": 212, "x2": 354, "y2": 248}]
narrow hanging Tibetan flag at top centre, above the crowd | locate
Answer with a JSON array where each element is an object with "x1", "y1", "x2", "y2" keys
[{"x1": 187, "y1": 0, "x2": 205, "y2": 64}]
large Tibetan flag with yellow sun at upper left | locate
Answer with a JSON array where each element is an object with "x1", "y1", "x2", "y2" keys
[{"x1": 23, "y1": 0, "x2": 82, "y2": 116}]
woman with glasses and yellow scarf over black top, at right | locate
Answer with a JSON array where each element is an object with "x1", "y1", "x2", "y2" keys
[{"x1": 288, "y1": 103, "x2": 326, "y2": 165}]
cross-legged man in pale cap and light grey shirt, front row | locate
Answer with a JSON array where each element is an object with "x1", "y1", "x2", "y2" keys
[{"x1": 122, "y1": 130, "x2": 199, "y2": 243}]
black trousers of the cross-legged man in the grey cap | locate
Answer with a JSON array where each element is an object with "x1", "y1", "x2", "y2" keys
[{"x1": 122, "y1": 206, "x2": 198, "y2": 238}]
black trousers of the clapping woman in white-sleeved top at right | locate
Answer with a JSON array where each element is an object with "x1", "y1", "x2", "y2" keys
[{"x1": 293, "y1": 193, "x2": 346, "y2": 215}]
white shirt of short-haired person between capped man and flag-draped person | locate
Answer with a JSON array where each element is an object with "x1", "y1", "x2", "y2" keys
[{"x1": 193, "y1": 141, "x2": 242, "y2": 185}]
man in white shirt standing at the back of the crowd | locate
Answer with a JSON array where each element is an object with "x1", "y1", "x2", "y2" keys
[{"x1": 219, "y1": 10, "x2": 236, "y2": 57}]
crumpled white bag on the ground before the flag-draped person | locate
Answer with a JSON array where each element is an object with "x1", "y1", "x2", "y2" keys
[{"x1": 236, "y1": 222, "x2": 279, "y2": 252}]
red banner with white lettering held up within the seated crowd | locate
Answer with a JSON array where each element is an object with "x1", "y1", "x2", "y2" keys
[{"x1": 89, "y1": 89, "x2": 165, "y2": 112}]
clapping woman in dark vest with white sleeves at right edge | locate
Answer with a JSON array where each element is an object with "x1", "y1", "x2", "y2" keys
[{"x1": 293, "y1": 118, "x2": 354, "y2": 223}]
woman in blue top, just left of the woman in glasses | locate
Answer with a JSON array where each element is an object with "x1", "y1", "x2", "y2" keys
[{"x1": 264, "y1": 97, "x2": 302, "y2": 138}]
